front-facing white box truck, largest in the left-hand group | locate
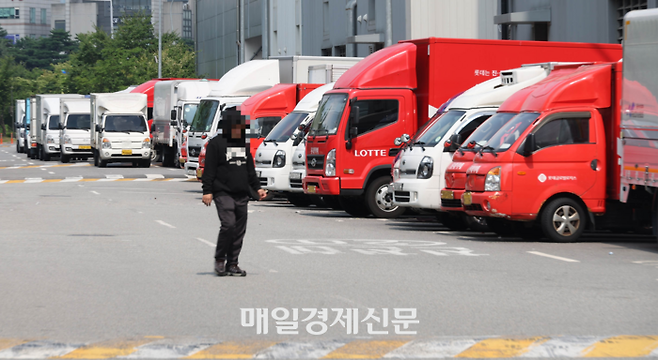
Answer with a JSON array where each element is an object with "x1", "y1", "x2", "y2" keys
[{"x1": 90, "y1": 93, "x2": 151, "y2": 167}]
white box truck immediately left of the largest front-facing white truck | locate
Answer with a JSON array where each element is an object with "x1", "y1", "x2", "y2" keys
[{"x1": 59, "y1": 98, "x2": 93, "y2": 163}]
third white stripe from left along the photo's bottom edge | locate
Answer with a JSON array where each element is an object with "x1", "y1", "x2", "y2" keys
[{"x1": 254, "y1": 340, "x2": 348, "y2": 359}]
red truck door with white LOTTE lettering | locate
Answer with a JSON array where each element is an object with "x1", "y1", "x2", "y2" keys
[{"x1": 336, "y1": 97, "x2": 406, "y2": 189}]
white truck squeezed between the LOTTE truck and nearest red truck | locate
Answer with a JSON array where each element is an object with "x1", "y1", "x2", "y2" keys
[{"x1": 389, "y1": 64, "x2": 552, "y2": 224}]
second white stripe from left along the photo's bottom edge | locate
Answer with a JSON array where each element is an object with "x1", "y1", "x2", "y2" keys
[{"x1": 125, "y1": 339, "x2": 217, "y2": 359}]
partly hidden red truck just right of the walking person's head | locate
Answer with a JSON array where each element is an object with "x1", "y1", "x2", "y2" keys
[{"x1": 239, "y1": 84, "x2": 324, "y2": 159}]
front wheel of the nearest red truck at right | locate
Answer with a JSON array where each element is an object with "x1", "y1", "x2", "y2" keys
[{"x1": 541, "y1": 198, "x2": 587, "y2": 242}]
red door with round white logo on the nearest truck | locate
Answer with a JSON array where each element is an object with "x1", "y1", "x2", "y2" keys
[{"x1": 512, "y1": 112, "x2": 605, "y2": 214}]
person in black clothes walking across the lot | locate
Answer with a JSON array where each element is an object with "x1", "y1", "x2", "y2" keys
[{"x1": 201, "y1": 113, "x2": 267, "y2": 276}]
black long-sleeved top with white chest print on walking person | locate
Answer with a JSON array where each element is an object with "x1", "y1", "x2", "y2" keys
[{"x1": 201, "y1": 135, "x2": 260, "y2": 197}]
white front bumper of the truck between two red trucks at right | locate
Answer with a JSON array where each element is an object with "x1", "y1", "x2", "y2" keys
[{"x1": 390, "y1": 179, "x2": 441, "y2": 210}]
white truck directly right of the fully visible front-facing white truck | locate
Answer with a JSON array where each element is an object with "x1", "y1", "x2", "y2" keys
[{"x1": 152, "y1": 79, "x2": 213, "y2": 167}]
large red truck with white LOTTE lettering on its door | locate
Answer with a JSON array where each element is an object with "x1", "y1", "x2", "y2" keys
[{"x1": 303, "y1": 38, "x2": 621, "y2": 217}]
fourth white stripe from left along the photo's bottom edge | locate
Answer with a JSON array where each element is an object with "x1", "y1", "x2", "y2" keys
[{"x1": 384, "y1": 338, "x2": 485, "y2": 359}]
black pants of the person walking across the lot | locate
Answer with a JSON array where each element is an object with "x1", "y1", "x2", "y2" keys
[{"x1": 214, "y1": 195, "x2": 249, "y2": 265}]
